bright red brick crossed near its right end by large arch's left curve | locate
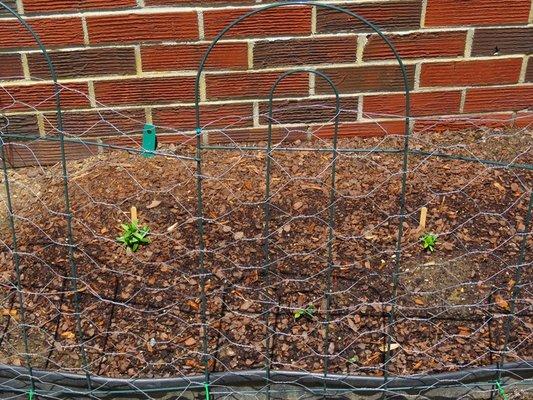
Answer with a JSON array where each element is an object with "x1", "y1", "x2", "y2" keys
[{"x1": 141, "y1": 43, "x2": 248, "y2": 71}]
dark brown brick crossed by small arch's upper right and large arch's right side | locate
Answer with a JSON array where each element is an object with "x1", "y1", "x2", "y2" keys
[{"x1": 316, "y1": 65, "x2": 414, "y2": 94}]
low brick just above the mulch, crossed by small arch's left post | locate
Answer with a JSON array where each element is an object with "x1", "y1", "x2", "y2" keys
[{"x1": 209, "y1": 126, "x2": 307, "y2": 144}]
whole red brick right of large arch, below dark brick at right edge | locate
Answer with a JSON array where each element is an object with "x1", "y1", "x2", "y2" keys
[{"x1": 420, "y1": 58, "x2": 522, "y2": 86}]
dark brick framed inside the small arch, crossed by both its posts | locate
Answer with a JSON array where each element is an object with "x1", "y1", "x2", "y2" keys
[{"x1": 259, "y1": 98, "x2": 357, "y2": 125}]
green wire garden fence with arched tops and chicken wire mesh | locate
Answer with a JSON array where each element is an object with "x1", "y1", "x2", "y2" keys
[{"x1": 0, "y1": 1, "x2": 533, "y2": 399}]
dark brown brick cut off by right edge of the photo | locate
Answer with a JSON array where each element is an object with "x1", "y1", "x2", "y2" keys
[{"x1": 472, "y1": 28, "x2": 533, "y2": 56}]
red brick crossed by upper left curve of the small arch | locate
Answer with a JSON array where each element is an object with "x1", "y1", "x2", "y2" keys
[{"x1": 206, "y1": 72, "x2": 309, "y2": 100}]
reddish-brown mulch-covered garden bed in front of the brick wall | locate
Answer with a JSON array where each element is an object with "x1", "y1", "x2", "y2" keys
[{"x1": 0, "y1": 131, "x2": 533, "y2": 377}]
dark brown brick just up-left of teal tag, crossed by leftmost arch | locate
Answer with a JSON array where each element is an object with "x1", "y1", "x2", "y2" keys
[{"x1": 44, "y1": 110, "x2": 146, "y2": 138}]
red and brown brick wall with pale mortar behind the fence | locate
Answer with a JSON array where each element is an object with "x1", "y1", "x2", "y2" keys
[{"x1": 0, "y1": 0, "x2": 533, "y2": 162}]
